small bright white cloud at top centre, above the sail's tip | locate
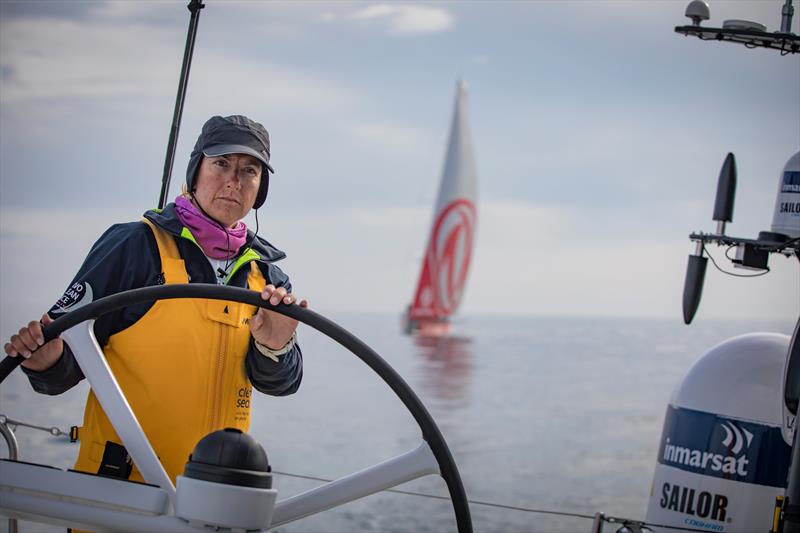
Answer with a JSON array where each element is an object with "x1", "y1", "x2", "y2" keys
[{"x1": 351, "y1": 4, "x2": 453, "y2": 33}]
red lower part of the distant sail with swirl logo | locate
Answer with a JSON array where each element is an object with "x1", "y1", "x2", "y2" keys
[{"x1": 412, "y1": 198, "x2": 477, "y2": 318}]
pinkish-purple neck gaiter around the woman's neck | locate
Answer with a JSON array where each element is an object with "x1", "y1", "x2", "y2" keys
[{"x1": 175, "y1": 196, "x2": 247, "y2": 259}]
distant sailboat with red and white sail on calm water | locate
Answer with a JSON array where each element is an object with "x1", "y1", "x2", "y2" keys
[{"x1": 405, "y1": 80, "x2": 478, "y2": 335}]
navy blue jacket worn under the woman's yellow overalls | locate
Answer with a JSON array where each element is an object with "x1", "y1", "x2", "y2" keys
[{"x1": 23, "y1": 204, "x2": 303, "y2": 396}]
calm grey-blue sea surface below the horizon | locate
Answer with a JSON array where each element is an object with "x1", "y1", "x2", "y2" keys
[{"x1": 0, "y1": 314, "x2": 794, "y2": 532}]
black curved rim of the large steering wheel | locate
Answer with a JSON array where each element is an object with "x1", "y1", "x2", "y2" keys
[{"x1": 0, "y1": 283, "x2": 472, "y2": 533}]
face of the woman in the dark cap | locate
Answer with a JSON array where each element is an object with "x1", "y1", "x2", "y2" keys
[{"x1": 194, "y1": 154, "x2": 261, "y2": 228}]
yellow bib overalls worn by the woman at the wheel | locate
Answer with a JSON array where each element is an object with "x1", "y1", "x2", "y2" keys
[{"x1": 75, "y1": 216, "x2": 266, "y2": 483}]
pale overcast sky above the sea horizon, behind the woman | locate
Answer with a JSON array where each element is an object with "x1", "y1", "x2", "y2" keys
[{"x1": 0, "y1": 0, "x2": 800, "y2": 334}]
